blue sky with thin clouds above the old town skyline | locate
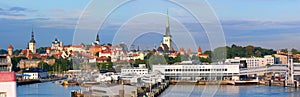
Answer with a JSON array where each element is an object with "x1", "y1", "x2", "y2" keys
[{"x1": 0, "y1": 0, "x2": 300, "y2": 51}]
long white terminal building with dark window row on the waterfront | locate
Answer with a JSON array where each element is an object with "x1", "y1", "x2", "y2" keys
[{"x1": 152, "y1": 65, "x2": 240, "y2": 81}]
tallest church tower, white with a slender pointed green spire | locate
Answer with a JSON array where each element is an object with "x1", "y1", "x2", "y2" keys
[{"x1": 163, "y1": 10, "x2": 172, "y2": 48}]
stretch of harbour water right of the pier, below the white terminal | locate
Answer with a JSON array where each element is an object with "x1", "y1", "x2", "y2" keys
[{"x1": 161, "y1": 85, "x2": 300, "y2": 97}]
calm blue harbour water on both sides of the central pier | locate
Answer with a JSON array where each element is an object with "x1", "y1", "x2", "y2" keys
[{"x1": 17, "y1": 82, "x2": 300, "y2": 97}]
